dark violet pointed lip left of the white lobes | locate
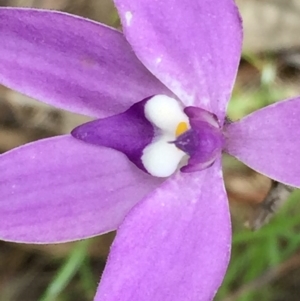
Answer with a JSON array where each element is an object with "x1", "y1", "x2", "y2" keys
[{"x1": 72, "y1": 98, "x2": 154, "y2": 172}]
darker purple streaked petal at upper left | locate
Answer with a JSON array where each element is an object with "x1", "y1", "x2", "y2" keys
[{"x1": 0, "y1": 8, "x2": 170, "y2": 117}]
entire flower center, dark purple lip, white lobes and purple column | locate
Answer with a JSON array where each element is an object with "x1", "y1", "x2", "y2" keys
[{"x1": 72, "y1": 95, "x2": 223, "y2": 177}]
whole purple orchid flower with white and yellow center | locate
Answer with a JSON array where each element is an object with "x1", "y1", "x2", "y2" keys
[{"x1": 0, "y1": 0, "x2": 300, "y2": 301}]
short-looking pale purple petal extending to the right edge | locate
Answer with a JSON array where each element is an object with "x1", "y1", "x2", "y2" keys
[{"x1": 225, "y1": 98, "x2": 300, "y2": 187}]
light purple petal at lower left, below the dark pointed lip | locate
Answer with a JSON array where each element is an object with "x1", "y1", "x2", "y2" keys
[{"x1": 0, "y1": 136, "x2": 161, "y2": 243}]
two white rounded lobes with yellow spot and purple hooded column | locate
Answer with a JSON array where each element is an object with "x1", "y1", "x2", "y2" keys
[{"x1": 141, "y1": 95, "x2": 223, "y2": 177}]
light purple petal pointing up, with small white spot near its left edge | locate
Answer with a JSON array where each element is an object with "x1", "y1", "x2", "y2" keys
[{"x1": 115, "y1": 0, "x2": 242, "y2": 123}]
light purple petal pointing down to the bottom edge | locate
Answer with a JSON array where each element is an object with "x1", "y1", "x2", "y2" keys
[{"x1": 95, "y1": 160, "x2": 231, "y2": 301}]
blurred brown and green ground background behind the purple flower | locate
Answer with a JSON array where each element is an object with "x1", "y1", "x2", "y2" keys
[{"x1": 0, "y1": 0, "x2": 300, "y2": 301}]
